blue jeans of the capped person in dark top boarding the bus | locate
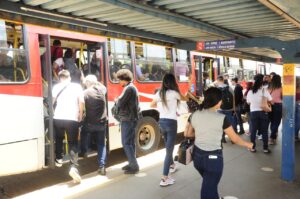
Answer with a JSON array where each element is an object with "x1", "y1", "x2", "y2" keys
[{"x1": 81, "y1": 122, "x2": 106, "y2": 167}]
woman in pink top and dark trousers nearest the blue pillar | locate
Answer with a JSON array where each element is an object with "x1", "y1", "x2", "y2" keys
[{"x1": 269, "y1": 75, "x2": 282, "y2": 145}]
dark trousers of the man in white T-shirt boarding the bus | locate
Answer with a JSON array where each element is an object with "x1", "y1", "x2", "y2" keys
[{"x1": 54, "y1": 119, "x2": 79, "y2": 167}]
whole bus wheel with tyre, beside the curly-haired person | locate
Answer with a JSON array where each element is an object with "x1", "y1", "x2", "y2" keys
[{"x1": 135, "y1": 116, "x2": 160, "y2": 156}]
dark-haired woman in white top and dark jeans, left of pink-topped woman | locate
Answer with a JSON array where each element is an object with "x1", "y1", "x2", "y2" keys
[{"x1": 247, "y1": 74, "x2": 272, "y2": 153}]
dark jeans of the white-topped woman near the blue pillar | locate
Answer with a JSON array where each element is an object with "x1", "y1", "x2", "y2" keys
[{"x1": 250, "y1": 111, "x2": 269, "y2": 149}]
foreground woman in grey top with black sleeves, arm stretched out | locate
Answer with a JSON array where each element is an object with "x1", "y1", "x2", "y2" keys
[{"x1": 189, "y1": 87, "x2": 253, "y2": 199}]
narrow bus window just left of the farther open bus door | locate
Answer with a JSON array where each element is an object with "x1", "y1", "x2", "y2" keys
[{"x1": 174, "y1": 49, "x2": 191, "y2": 81}]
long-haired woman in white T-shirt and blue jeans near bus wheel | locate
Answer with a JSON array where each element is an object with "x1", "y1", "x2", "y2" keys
[{"x1": 150, "y1": 73, "x2": 187, "y2": 186}]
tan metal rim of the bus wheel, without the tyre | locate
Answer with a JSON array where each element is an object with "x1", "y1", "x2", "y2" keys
[{"x1": 138, "y1": 125, "x2": 155, "y2": 150}]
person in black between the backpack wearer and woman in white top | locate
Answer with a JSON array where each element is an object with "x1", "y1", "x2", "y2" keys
[{"x1": 231, "y1": 77, "x2": 245, "y2": 135}]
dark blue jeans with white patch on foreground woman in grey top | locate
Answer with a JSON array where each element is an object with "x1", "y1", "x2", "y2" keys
[{"x1": 193, "y1": 146, "x2": 224, "y2": 199}]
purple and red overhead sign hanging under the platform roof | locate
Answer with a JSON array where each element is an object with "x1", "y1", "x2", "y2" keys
[{"x1": 196, "y1": 40, "x2": 236, "y2": 50}]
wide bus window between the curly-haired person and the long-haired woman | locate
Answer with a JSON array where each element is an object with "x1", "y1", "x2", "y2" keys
[{"x1": 135, "y1": 42, "x2": 173, "y2": 82}]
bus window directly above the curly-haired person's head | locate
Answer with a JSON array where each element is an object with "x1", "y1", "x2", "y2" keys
[{"x1": 108, "y1": 39, "x2": 132, "y2": 83}]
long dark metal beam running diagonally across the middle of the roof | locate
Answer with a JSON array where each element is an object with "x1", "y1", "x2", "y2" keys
[{"x1": 100, "y1": 0, "x2": 246, "y2": 38}]
